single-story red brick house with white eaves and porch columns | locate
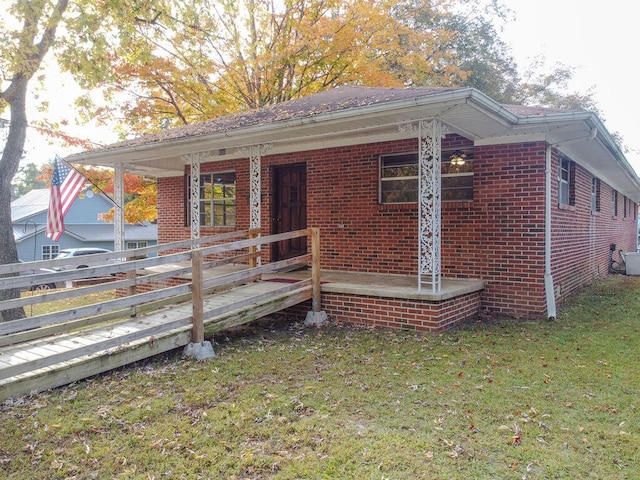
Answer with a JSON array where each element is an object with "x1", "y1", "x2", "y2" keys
[{"x1": 68, "y1": 86, "x2": 640, "y2": 330}]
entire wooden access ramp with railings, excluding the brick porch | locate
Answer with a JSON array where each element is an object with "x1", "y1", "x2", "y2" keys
[{"x1": 0, "y1": 229, "x2": 320, "y2": 401}]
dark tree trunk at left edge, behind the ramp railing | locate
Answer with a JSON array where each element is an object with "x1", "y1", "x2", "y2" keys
[{"x1": 0, "y1": 81, "x2": 27, "y2": 322}]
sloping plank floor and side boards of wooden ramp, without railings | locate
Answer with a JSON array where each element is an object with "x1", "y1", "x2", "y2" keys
[{"x1": 0, "y1": 281, "x2": 311, "y2": 401}]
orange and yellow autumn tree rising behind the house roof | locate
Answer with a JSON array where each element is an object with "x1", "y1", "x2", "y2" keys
[{"x1": 83, "y1": 0, "x2": 513, "y2": 133}]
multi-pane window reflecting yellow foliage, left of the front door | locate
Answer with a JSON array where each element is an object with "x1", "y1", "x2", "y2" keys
[{"x1": 186, "y1": 172, "x2": 236, "y2": 227}]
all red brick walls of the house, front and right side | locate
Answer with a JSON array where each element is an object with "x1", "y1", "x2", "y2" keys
[{"x1": 158, "y1": 137, "x2": 636, "y2": 316}]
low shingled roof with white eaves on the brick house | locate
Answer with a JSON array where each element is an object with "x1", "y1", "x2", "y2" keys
[{"x1": 67, "y1": 86, "x2": 640, "y2": 202}]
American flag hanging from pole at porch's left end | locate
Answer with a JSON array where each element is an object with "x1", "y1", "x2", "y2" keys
[{"x1": 47, "y1": 157, "x2": 86, "y2": 242}]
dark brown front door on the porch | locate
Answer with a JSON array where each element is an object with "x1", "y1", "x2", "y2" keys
[{"x1": 272, "y1": 164, "x2": 307, "y2": 260}]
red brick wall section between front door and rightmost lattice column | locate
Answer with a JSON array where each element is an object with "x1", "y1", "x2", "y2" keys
[{"x1": 306, "y1": 140, "x2": 418, "y2": 274}]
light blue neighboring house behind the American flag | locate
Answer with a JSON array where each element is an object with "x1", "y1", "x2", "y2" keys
[{"x1": 11, "y1": 189, "x2": 158, "y2": 262}]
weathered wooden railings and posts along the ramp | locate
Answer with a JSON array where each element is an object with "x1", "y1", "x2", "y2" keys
[{"x1": 0, "y1": 228, "x2": 320, "y2": 343}]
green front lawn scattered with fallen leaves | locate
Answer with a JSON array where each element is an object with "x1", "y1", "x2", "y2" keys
[{"x1": 0, "y1": 276, "x2": 640, "y2": 479}]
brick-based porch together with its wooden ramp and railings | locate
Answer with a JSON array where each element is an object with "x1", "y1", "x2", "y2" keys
[{"x1": 0, "y1": 229, "x2": 484, "y2": 400}]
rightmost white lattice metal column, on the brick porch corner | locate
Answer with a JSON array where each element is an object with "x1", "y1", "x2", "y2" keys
[{"x1": 418, "y1": 120, "x2": 445, "y2": 293}]
